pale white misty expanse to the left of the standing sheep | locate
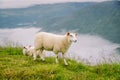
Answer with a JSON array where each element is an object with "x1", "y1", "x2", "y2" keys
[{"x1": 0, "y1": 28, "x2": 40, "y2": 46}]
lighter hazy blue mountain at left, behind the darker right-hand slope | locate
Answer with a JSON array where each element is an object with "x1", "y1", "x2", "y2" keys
[{"x1": 0, "y1": 3, "x2": 94, "y2": 28}]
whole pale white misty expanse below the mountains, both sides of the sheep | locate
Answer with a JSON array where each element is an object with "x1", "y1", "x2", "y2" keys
[{"x1": 0, "y1": 27, "x2": 120, "y2": 65}]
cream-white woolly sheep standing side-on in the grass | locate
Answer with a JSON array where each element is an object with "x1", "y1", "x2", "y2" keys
[{"x1": 33, "y1": 32, "x2": 77, "y2": 65}]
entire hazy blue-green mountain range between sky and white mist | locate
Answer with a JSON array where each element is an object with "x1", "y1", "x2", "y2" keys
[{"x1": 0, "y1": 1, "x2": 120, "y2": 43}]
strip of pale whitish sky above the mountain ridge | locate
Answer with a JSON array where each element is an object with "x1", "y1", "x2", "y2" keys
[{"x1": 0, "y1": 0, "x2": 106, "y2": 8}]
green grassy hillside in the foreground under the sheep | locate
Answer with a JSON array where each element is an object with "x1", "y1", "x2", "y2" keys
[{"x1": 0, "y1": 47, "x2": 120, "y2": 80}]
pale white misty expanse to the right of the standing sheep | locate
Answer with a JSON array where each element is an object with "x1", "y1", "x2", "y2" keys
[{"x1": 68, "y1": 35, "x2": 120, "y2": 64}]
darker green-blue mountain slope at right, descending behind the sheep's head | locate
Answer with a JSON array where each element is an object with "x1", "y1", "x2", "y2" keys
[{"x1": 57, "y1": 2, "x2": 120, "y2": 42}]
